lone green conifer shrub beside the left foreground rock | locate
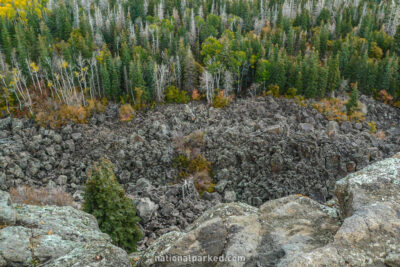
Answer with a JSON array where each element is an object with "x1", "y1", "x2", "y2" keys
[{"x1": 83, "y1": 159, "x2": 143, "y2": 252}]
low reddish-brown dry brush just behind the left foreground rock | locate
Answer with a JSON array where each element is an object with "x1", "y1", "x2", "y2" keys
[{"x1": 10, "y1": 186, "x2": 76, "y2": 207}]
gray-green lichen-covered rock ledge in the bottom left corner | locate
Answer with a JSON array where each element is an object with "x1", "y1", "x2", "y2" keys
[{"x1": 0, "y1": 191, "x2": 131, "y2": 267}]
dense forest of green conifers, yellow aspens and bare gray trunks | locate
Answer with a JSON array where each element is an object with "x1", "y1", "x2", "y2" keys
[{"x1": 0, "y1": 0, "x2": 400, "y2": 115}]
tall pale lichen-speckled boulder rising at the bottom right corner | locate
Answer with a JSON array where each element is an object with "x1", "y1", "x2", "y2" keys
[{"x1": 288, "y1": 154, "x2": 400, "y2": 267}]
